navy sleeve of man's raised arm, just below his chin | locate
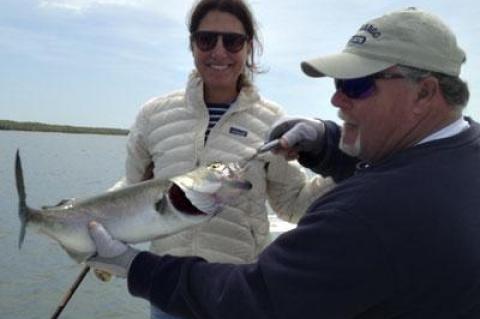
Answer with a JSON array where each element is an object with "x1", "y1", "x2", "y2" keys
[{"x1": 298, "y1": 121, "x2": 359, "y2": 183}]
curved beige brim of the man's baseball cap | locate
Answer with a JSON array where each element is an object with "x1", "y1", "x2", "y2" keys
[{"x1": 301, "y1": 52, "x2": 395, "y2": 79}]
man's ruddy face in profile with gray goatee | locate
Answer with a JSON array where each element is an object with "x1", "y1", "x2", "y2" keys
[{"x1": 332, "y1": 67, "x2": 417, "y2": 162}]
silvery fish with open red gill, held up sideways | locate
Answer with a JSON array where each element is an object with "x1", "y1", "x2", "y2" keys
[{"x1": 15, "y1": 150, "x2": 252, "y2": 262}]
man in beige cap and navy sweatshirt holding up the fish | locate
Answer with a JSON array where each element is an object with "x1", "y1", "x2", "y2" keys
[{"x1": 86, "y1": 9, "x2": 480, "y2": 319}]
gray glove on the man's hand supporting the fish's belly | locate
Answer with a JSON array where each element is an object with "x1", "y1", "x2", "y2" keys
[{"x1": 87, "y1": 221, "x2": 140, "y2": 278}]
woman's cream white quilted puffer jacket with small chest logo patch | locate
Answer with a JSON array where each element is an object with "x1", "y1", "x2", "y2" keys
[{"x1": 119, "y1": 72, "x2": 334, "y2": 263}]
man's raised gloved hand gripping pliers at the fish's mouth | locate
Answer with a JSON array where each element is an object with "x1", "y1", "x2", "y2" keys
[{"x1": 266, "y1": 117, "x2": 325, "y2": 160}]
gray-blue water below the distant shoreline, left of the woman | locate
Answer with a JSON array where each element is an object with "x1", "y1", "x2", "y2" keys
[{"x1": 0, "y1": 131, "x2": 149, "y2": 319}]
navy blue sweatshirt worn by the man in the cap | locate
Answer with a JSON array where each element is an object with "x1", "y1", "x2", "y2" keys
[{"x1": 128, "y1": 121, "x2": 480, "y2": 319}]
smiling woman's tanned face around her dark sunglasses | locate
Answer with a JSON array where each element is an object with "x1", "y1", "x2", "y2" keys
[{"x1": 192, "y1": 11, "x2": 251, "y2": 98}]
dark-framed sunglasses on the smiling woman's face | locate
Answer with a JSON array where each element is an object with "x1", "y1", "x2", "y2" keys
[{"x1": 190, "y1": 31, "x2": 248, "y2": 53}]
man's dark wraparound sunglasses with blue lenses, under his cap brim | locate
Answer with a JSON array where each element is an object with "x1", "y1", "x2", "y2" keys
[{"x1": 335, "y1": 72, "x2": 405, "y2": 99}]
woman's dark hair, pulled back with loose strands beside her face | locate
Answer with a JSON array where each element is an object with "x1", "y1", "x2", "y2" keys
[{"x1": 187, "y1": 0, "x2": 262, "y2": 90}]
